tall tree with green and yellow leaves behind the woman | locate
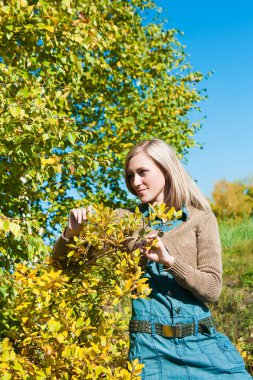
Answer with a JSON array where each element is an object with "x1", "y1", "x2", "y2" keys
[{"x1": 0, "y1": 0, "x2": 206, "y2": 267}]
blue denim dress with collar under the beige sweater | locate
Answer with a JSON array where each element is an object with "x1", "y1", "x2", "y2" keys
[{"x1": 129, "y1": 206, "x2": 251, "y2": 380}]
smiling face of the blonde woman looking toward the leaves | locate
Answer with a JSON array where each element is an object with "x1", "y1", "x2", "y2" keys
[{"x1": 127, "y1": 152, "x2": 167, "y2": 205}]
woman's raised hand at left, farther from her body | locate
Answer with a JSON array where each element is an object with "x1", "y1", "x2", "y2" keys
[{"x1": 64, "y1": 206, "x2": 92, "y2": 239}]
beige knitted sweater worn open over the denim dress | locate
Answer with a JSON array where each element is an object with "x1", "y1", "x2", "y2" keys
[{"x1": 52, "y1": 207, "x2": 222, "y2": 302}]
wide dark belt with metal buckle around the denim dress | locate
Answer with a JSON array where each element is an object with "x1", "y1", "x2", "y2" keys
[{"x1": 129, "y1": 316, "x2": 214, "y2": 338}]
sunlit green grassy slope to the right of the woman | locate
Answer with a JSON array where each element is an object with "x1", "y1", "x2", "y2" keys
[{"x1": 211, "y1": 219, "x2": 253, "y2": 374}]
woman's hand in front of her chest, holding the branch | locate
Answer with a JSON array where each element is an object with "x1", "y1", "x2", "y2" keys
[{"x1": 140, "y1": 234, "x2": 175, "y2": 267}]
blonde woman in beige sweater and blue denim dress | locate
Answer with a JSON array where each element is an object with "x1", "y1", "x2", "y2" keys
[{"x1": 53, "y1": 139, "x2": 251, "y2": 380}]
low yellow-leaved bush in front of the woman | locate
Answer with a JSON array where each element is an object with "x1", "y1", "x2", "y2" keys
[{"x1": 0, "y1": 205, "x2": 150, "y2": 380}]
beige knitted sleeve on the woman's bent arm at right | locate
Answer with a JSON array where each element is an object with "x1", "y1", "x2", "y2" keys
[{"x1": 164, "y1": 212, "x2": 222, "y2": 302}]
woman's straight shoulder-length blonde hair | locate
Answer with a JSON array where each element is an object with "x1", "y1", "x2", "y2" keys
[{"x1": 125, "y1": 139, "x2": 211, "y2": 210}]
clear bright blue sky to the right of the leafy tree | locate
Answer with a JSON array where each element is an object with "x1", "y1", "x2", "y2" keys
[{"x1": 152, "y1": 0, "x2": 253, "y2": 196}]
